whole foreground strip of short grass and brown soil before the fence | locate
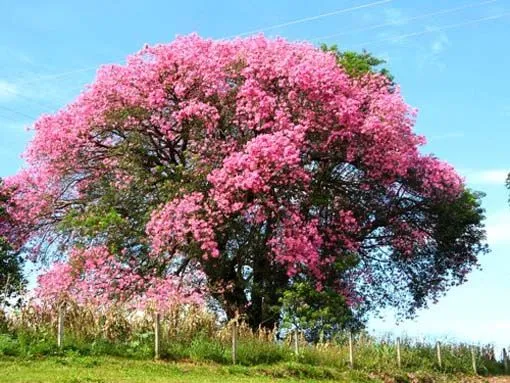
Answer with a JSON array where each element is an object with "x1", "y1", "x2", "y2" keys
[{"x1": 0, "y1": 356, "x2": 484, "y2": 383}]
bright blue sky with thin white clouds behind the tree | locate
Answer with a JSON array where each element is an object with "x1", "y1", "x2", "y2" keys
[{"x1": 0, "y1": 0, "x2": 510, "y2": 346}]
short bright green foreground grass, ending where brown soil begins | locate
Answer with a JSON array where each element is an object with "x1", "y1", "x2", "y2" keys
[{"x1": 0, "y1": 357, "x2": 362, "y2": 383}]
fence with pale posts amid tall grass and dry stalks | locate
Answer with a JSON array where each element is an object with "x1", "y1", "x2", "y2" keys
[{"x1": 0, "y1": 306, "x2": 502, "y2": 375}]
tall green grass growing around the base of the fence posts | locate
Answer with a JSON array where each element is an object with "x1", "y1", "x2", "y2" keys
[{"x1": 0, "y1": 332, "x2": 503, "y2": 379}]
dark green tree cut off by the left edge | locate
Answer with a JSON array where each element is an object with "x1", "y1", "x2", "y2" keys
[{"x1": 0, "y1": 179, "x2": 26, "y2": 306}]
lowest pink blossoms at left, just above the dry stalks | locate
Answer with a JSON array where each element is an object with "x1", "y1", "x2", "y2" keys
[{"x1": 35, "y1": 246, "x2": 204, "y2": 311}]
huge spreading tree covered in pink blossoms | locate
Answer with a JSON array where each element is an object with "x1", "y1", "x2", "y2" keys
[{"x1": 6, "y1": 35, "x2": 486, "y2": 327}]
